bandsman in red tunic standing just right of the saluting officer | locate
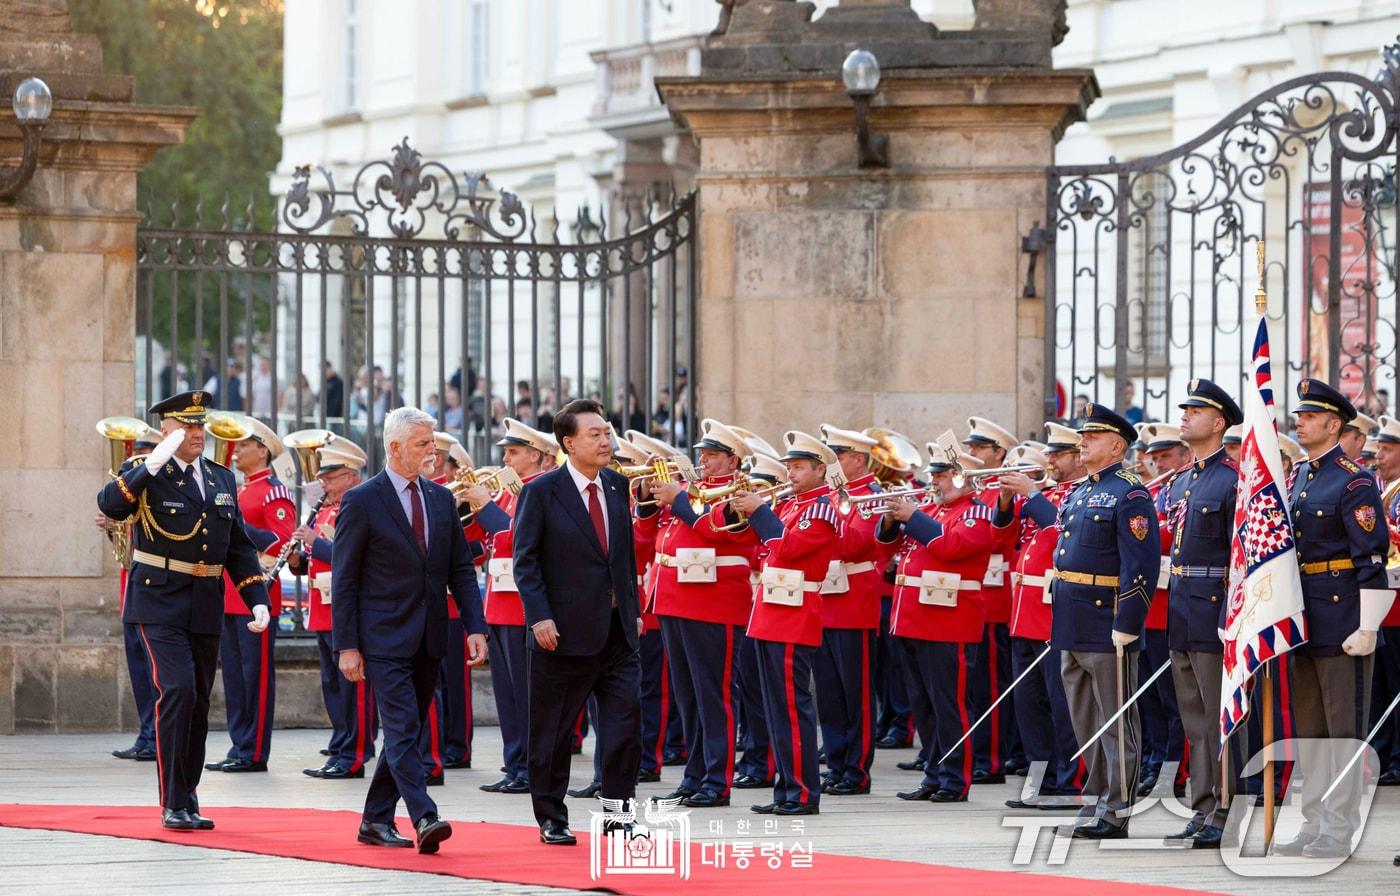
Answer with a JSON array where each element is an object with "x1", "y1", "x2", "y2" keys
[{"x1": 204, "y1": 417, "x2": 297, "y2": 771}]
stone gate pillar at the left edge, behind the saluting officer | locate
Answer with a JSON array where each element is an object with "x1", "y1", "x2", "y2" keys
[{"x1": 0, "y1": 0, "x2": 195, "y2": 734}]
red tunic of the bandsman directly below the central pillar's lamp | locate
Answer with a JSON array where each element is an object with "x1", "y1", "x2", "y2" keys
[{"x1": 822, "y1": 473, "x2": 895, "y2": 629}]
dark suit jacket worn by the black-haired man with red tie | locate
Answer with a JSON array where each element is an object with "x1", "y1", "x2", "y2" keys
[{"x1": 514, "y1": 466, "x2": 641, "y2": 657}]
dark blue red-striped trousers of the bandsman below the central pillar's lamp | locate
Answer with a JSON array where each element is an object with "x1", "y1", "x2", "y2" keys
[{"x1": 812, "y1": 629, "x2": 875, "y2": 787}]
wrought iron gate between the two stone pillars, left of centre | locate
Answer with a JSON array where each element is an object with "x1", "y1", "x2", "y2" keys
[{"x1": 137, "y1": 140, "x2": 699, "y2": 469}]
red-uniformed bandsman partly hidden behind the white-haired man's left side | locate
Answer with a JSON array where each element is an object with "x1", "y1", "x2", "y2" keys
[{"x1": 296, "y1": 437, "x2": 378, "y2": 780}]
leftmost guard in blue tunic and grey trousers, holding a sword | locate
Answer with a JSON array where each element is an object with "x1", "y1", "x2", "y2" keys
[{"x1": 1050, "y1": 403, "x2": 1162, "y2": 839}]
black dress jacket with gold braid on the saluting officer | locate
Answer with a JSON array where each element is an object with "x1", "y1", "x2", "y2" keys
[{"x1": 97, "y1": 458, "x2": 267, "y2": 634}]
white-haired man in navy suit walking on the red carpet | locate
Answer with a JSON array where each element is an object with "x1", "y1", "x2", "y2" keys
[{"x1": 330, "y1": 407, "x2": 486, "y2": 853}]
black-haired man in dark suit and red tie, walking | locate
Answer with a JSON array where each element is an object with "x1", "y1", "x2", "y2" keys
[{"x1": 514, "y1": 399, "x2": 641, "y2": 846}]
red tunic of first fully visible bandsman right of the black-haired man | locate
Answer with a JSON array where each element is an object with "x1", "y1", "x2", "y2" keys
[{"x1": 637, "y1": 475, "x2": 761, "y2": 626}]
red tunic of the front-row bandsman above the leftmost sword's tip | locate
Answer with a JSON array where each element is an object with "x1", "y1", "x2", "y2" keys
[{"x1": 889, "y1": 494, "x2": 1012, "y2": 644}]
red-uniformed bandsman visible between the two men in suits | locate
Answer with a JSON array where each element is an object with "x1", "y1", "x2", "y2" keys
[{"x1": 465, "y1": 417, "x2": 559, "y2": 794}]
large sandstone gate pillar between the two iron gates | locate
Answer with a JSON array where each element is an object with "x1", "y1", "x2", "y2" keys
[{"x1": 657, "y1": 0, "x2": 1098, "y2": 441}]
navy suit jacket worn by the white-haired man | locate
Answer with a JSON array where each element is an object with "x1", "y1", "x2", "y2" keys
[{"x1": 330, "y1": 470, "x2": 486, "y2": 657}]
